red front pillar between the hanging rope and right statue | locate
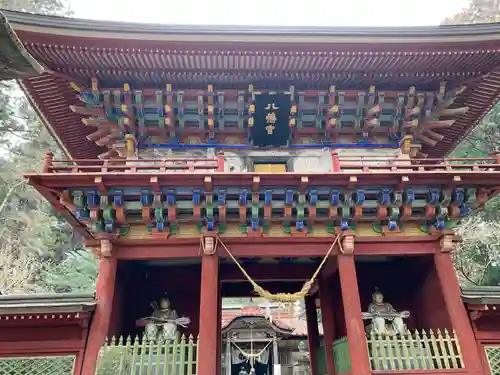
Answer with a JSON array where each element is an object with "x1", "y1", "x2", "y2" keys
[{"x1": 337, "y1": 254, "x2": 371, "y2": 375}]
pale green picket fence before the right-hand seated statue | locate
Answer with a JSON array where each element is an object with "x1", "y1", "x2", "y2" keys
[{"x1": 368, "y1": 330, "x2": 463, "y2": 370}]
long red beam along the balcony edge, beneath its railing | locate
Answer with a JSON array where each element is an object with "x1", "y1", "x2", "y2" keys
[{"x1": 24, "y1": 171, "x2": 500, "y2": 194}]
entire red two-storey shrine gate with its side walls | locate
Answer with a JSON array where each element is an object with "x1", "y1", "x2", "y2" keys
[{"x1": 0, "y1": 7, "x2": 500, "y2": 375}]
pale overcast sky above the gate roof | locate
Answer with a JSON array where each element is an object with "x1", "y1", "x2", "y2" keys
[{"x1": 72, "y1": 0, "x2": 468, "y2": 26}]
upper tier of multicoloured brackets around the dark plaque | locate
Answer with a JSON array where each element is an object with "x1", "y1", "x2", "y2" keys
[{"x1": 71, "y1": 78, "x2": 468, "y2": 157}]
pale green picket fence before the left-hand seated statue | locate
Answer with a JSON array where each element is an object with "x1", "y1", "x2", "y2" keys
[{"x1": 96, "y1": 335, "x2": 198, "y2": 375}]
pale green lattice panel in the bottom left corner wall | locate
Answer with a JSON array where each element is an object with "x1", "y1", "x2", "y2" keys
[{"x1": 0, "y1": 355, "x2": 75, "y2": 375}]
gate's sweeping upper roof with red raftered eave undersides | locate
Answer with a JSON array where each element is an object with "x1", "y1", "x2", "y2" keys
[{"x1": 2, "y1": 12, "x2": 500, "y2": 158}]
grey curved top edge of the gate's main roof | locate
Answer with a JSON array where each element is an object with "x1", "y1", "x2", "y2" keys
[{"x1": 3, "y1": 11, "x2": 500, "y2": 44}]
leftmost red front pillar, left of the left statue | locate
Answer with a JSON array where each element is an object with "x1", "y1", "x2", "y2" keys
[{"x1": 82, "y1": 258, "x2": 118, "y2": 375}]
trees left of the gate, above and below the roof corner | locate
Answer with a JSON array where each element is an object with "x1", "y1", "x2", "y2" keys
[{"x1": 0, "y1": 0, "x2": 97, "y2": 294}]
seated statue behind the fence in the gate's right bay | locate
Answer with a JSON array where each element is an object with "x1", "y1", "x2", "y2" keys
[{"x1": 363, "y1": 289, "x2": 410, "y2": 335}]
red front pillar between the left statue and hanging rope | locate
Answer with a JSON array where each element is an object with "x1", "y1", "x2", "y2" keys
[{"x1": 197, "y1": 253, "x2": 221, "y2": 375}]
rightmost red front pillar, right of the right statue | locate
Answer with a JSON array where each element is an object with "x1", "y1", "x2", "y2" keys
[{"x1": 434, "y1": 252, "x2": 482, "y2": 373}]
